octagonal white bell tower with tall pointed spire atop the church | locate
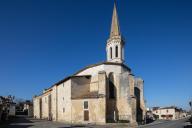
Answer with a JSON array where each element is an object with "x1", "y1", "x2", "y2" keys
[{"x1": 106, "y1": 2, "x2": 125, "y2": 63}]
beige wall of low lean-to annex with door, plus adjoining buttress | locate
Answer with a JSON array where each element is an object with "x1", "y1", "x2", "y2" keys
[{"x1": 71, "y1": 72, "x2": 106, "y2": 123}]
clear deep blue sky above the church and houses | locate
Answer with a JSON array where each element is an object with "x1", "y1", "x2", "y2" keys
[{"x1": 0, "y1": 0, "x2": 192, "y2": 108}]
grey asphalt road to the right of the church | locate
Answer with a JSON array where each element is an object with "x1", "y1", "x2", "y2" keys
[{"x1": 138, "y1": 119, "x2": 192, "y2": 128}]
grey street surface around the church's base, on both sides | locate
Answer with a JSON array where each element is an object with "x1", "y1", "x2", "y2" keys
[{"x1": 0, "y1": 116, "x2": 191, "y2": 128}]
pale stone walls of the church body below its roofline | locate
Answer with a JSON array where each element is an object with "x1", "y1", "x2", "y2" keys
[{"x1": 33, "y1": 65, "x2": 144, "y2": 123}]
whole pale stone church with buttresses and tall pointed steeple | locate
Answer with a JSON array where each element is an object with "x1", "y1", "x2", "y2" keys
[{"x1": 33, "y1": 4, "x2": 145, "y2": 124}]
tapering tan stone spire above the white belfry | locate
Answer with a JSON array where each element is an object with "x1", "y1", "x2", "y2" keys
[{"x1": 110, "y1": 1, "x2": 121, "y2": 38}]
